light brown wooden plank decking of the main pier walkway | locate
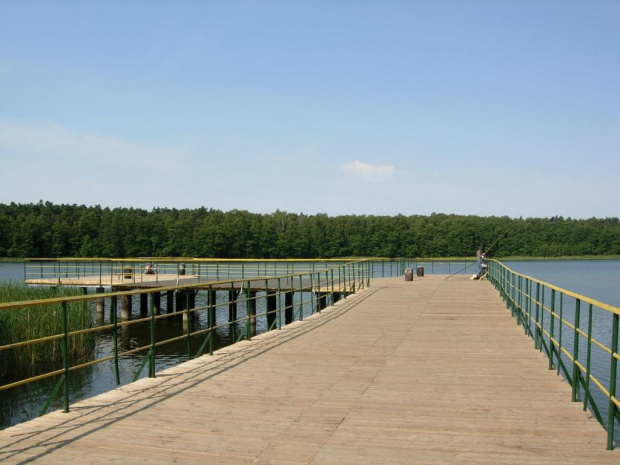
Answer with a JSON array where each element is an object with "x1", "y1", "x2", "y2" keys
[{"x1": 0, "y1": 276, "x2": 620, "y2": 465}]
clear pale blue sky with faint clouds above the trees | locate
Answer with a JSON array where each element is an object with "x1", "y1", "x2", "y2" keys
[{"x1": 0, "y1": 0, "x2": 620, "y2": 218}]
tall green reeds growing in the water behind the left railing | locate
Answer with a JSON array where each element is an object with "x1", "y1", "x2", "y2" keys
[{"x1": 0, "y1": 282, "x2": 95, "y2": 379}]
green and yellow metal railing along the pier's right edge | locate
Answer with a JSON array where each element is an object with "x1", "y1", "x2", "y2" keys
[{"x1": 488, "y1": 260, "x2": 620, "y2": 450}]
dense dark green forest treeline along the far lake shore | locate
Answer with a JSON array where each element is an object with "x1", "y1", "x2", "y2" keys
[{"x1": 0, "y1": 202, "x2": 620, "y2": 258}]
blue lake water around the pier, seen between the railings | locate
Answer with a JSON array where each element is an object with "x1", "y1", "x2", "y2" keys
[{"x1": 0, "y1": 260, "x2": 620, "y2": 436}]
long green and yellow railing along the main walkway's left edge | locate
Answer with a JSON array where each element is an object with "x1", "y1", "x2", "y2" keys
[{"x1": 0, "y1": 260, "x2": 370, "y2": 415}]
